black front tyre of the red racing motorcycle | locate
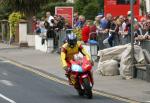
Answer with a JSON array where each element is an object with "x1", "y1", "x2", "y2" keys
[{"x1": 83, "y1": 78, "x2": 93, "y2": 99}]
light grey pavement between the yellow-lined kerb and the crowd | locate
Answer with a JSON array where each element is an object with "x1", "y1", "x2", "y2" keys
[{"x1": 0, "y1": 43, "x2": 150, "y2": 103}]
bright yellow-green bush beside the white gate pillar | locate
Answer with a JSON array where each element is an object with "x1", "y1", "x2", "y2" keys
[{"x1": 9, "y1": 12, "x2": 23, "y2": 36}]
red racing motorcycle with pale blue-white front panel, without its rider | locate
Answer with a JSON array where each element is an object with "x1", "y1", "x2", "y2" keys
[{"x1": 68, "y1": 57, "x2": 94, "y2": 99}]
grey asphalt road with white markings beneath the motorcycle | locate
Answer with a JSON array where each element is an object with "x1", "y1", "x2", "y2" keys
[{"x1": 0, "y1": 60, "x2": 125, "y2": 103}]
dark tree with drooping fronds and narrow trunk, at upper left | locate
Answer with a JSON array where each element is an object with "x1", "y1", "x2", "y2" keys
[{"x1": 0, "y1": 0, "x2": 49, "y2": 33}]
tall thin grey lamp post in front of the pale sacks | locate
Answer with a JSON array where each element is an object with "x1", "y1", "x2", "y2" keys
[{"x1": 130, "y1": 0, "x2": 136, "y2": 78}]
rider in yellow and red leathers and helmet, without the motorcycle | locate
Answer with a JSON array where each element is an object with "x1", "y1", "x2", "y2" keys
[{"x1": 61, "y1": 33, "x2": 91, "y2": 72}]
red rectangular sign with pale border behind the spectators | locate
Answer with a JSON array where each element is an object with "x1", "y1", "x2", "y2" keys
[{"x1": 55, "y1": 7, "x2": 73, "y2": 27}]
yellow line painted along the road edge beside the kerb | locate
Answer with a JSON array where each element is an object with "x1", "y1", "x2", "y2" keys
[{"x1": 1, "y1": 58, "x2": 140, "y2": 103}]
